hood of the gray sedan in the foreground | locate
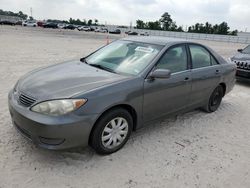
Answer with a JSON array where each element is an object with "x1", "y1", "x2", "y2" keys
[{"x1": 17, "y1": 61, "x2": 129, "y2": 100}]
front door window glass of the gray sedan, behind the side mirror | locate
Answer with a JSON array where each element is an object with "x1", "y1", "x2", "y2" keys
[{"x1": 156, "y1": 45, "x2": 187, "y2": 73}]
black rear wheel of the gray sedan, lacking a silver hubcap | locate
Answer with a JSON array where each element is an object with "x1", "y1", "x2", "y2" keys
[{"x1": 203, "y1": 85, "x2": 224, "y2": 113}]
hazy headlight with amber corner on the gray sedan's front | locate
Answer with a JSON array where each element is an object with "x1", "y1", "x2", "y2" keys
[{"x1": 31, "y1": 99, "x2": 87, "y2": 116}]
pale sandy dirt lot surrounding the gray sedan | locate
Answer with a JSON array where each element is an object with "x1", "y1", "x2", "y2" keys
[{"x1": 0, "y1": 26, "x2": 250, "y2": 188}]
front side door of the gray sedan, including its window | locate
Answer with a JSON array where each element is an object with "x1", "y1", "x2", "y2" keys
[{"x1": 143, "y1": 44, "x2": 191, "y2": 122}]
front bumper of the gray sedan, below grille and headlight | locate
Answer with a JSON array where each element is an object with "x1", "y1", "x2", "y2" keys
[{"x1": 8, "y1": 91, "x2": 98, "y2": 150}]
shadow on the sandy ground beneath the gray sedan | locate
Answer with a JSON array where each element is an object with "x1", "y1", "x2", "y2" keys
[{"x1": 24, "y1": 103, "x2": 231, "y2": 168}]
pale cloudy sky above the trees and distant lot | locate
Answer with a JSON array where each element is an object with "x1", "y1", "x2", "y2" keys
[{"x1": 0, "y1": 0, "x2": 250, "y2": 31}]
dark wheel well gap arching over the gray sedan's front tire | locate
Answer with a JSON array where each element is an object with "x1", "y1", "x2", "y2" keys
[{"x1": 89, "y1": 104, "x2": 137, "y2": 144}]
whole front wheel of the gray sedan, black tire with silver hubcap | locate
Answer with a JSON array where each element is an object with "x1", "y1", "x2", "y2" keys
[{"x1": 90, "y1": 108, "x2": 133, "y2": 155}]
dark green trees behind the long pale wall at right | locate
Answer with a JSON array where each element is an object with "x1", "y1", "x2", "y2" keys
[{"x1": 136, "y1": 12, "x2": 238, "y2": 35}]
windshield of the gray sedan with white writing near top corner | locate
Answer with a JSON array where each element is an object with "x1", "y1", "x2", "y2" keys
[{"x1": 86, "y1": 41, "x2": 163, "y2": 75}]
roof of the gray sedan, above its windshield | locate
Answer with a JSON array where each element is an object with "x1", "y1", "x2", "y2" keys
[{"x1": 122, "y1": 36, "x2": 189, "y2": 46}]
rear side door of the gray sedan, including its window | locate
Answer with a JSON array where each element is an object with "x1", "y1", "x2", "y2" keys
[{"x1": 188, "y1": 44, "x2": 222, "y2": 105}]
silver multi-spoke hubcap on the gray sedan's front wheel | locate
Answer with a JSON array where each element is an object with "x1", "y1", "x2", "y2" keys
[{"x1": 101, "y1": 117, "x2": 128, "y2": 149}]
